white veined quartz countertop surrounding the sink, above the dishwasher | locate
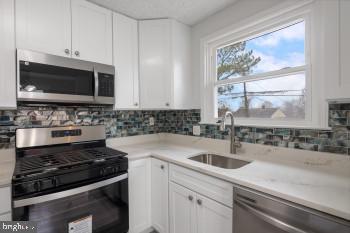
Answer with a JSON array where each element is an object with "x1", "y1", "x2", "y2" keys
[{"x1": 109, "y1": 137, "x2": 350, "y2": 220}]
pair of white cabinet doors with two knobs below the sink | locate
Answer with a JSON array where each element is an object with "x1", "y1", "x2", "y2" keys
[{"x1": 169, "y1": 182, "x2": 232, "y2": 233}]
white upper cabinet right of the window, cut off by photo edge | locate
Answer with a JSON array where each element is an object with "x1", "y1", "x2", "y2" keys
[{"x1": 321, "y1": 0, "x2": 350, "y2": 101}]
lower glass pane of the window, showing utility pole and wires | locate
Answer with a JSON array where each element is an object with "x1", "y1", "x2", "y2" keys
[{"x1": 217, "y1": 74, "x2": 306, "y2": 120}]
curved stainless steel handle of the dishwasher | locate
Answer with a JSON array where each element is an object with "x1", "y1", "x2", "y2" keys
[{"x1": 235, "y1": 200, "x2": 313, "y2": 233}]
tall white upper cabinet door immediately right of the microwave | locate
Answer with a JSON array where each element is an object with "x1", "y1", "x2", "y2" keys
[{"x1": 113, "y1": 13, "x2": 139, "y2": 109}]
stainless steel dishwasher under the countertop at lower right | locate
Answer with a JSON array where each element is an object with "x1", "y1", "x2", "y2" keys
[{"x1": 233, "y1": 187, "x2": 350, "y2": 233}]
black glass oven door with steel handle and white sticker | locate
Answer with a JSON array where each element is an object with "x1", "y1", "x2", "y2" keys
[{"x1": 13, "y1": 174, "x2": 129, "y2": 233}]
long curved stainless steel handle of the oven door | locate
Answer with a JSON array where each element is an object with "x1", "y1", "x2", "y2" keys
[{"x1": 13, "y1": 173, "x2": 128, "y2": 208}]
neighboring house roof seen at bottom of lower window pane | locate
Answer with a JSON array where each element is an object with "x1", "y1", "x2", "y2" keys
[{"x1": 234, "y1": 108, "x2": 286, "y2": 118}]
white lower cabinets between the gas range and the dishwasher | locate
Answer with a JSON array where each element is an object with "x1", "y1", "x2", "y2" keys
[{"x1": 129, "y1": 158, "x2": 233, "y2": 233}]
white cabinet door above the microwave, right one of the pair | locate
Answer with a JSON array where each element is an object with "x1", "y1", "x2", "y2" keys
[{"x1": 72, "y1": 0, "x2": 113, "y2": 65}]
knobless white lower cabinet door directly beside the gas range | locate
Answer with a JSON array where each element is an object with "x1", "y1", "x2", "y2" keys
[{"x1": 129, "y1": 159, "x2": 151, "y2": 233}]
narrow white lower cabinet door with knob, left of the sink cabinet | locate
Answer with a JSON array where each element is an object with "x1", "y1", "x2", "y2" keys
[{"x1": 151, "y1": 159, "x2": 169, "y2": 233}]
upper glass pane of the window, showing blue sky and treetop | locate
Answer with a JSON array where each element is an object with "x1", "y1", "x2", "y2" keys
[{"x1": 216, "y1": 21, "x2": 305, "y2": 80}]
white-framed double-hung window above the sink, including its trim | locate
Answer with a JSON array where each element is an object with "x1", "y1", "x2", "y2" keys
[{"x1": 199, "y1": 1, "x2": 330, "y2": 128}]
